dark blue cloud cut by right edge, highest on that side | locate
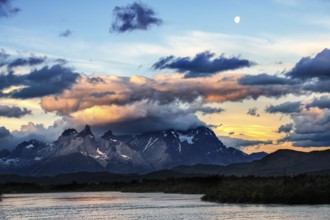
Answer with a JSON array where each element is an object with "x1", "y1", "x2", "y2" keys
[{"x1": 286, "y1": 49, "x2": 330, "y2": 79}]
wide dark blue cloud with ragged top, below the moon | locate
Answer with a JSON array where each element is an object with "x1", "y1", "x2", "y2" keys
[{"x1": 152, "y1": 51, "x2": 254, "y2": 78}]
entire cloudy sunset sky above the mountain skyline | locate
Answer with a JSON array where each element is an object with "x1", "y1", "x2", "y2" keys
[{"x1": 0, "y1": 0, "x2": 330, "y2": 153}]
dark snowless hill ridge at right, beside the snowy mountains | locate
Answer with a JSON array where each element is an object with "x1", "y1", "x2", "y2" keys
[{"x1": 173, "y1": 149, "x2": 330, "y2": 176}]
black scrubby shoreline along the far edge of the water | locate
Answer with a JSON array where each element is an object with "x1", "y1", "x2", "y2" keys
[{"x1": 0, "y1": 175, "x2": 330, "y2": 205}]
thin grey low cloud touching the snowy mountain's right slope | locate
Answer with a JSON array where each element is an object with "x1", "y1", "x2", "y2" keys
[{"x1": 219, "y1": 136, "x2": 273, "y2": 149}]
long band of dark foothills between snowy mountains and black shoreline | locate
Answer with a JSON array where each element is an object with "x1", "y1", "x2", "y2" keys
[{"x1": 0, "y1": 150, "x2": 330, "y2": 186}]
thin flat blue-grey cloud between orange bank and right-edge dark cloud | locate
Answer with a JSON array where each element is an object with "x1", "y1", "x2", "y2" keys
[{"x1": 238, "y1": 73, "x2": 296, "y2": 86}]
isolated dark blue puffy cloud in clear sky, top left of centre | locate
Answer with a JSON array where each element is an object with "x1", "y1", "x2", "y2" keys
[{"x1": 110, "y1": 2, "x2": 163, "y2": 33}]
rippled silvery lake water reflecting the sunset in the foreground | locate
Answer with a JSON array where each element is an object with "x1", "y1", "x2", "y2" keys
[{"x1": 0, "y1": 192, "x2": 330, "y2": 220}]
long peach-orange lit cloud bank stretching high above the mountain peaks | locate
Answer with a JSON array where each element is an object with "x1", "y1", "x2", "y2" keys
[{"x1": 41, "y1": 74, "x2": 296, "y2": 115}]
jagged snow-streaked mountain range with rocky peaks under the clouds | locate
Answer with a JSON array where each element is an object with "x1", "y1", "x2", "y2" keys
[{"x1": 0, "y1": 125, "x2": 266, "y2": 176}]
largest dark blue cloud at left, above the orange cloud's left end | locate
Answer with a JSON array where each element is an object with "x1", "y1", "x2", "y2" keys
[{"x1": 11, "y1": 64, "x2": 80, "y2": 99}]
